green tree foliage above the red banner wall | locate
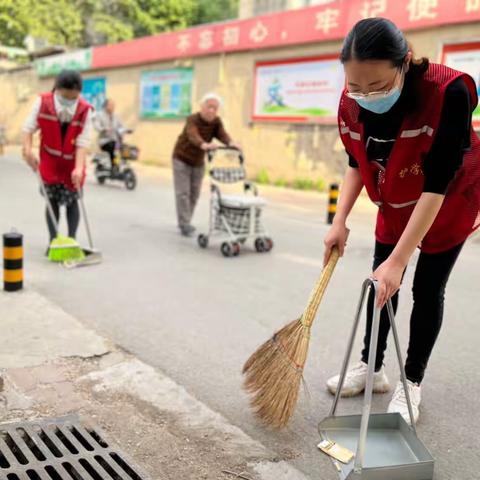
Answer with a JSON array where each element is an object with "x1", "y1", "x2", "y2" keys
[{"x1": 0, "y1": 0, "x2": 238, "y2": 47}]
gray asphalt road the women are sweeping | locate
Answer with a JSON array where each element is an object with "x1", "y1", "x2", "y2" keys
[{"x1": 0, "y1": 151, "x2": 480, "y2": 480}]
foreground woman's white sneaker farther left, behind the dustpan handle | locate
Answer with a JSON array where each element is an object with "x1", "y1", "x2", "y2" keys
[{"x1": 327, "y1": 362, "x2": 390, "y2": 397}]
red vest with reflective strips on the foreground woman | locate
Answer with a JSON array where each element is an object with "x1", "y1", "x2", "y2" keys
[{"x1": 338, "y1": 64, "x2": 480, "y2": 253}]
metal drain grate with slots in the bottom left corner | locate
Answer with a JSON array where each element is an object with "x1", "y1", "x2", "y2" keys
[{"x1": 0, "y1": 415, "x2": 149, "y2": 480}]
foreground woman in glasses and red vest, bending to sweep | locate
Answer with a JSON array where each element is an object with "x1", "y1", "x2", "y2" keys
[{"x1": 325, "y1": 18, "x2": 480, "y2": 421}]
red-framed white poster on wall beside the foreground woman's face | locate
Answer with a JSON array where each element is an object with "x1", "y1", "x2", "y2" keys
[{"x1": 253, "y1": 56, "x2": 345, "y2": 123}]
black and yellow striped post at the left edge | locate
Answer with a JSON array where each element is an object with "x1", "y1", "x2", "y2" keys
[{"x1": 3, "y1": 232, "x2": 23, "y2": 292}]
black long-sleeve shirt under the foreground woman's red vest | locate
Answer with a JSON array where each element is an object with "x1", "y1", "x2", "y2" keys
[{"x1": 349, "y1": 74, "x2": 472, "y2": 194}]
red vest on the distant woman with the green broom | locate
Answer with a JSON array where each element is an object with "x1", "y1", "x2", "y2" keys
[{"x1": 38, "y1": 92, "x2": 91, "y2": 191}]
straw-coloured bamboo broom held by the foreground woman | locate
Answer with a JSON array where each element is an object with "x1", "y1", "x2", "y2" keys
[{"x1": 243, "y1": 247, "x2": 339, "y2": 428}]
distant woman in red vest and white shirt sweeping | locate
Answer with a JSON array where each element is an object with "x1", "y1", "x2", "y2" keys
[{"x1": 23, "y1": 70, "x2": 92, "y2": 254}]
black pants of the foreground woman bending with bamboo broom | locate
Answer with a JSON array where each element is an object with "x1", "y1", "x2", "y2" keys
[{"x1": 362, "y1": 242, "x2": 463, "y2": 384}]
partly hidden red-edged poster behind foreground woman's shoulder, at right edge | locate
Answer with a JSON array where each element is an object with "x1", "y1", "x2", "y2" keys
[{"x1": 442, "y1": 42, "x2": 480, "y2": 128}]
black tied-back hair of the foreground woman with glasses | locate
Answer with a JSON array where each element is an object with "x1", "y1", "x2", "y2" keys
[{"x1": 340, "y1": 17, "x2": 428, "y2": 73}]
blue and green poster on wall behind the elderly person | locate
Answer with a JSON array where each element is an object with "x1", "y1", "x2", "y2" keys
[{"x1": 140, "y1": 68, "x2": 193, "y2": 118}]
